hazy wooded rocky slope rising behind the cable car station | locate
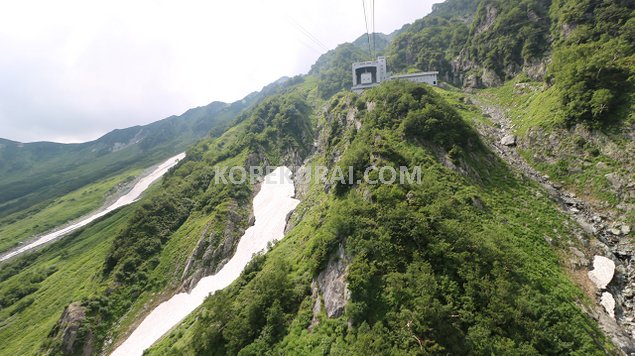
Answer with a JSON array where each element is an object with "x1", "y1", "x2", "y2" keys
[{"x1": 388, "y1": 0, "x2": 549, "y2": 83}]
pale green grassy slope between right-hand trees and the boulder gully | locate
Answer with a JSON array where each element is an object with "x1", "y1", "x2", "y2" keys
[{"x1": 477, "y1": 76, "x2": 635, "y2": 224}]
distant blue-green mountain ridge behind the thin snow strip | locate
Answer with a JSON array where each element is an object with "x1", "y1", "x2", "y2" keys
[{"x1": 0, "y1": 77, "x2": 288, "y2": 218}]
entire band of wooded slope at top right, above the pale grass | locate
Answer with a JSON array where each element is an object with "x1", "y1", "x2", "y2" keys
[{"x1": 387, "y1": 0, "x2": 635, "y2": 125}]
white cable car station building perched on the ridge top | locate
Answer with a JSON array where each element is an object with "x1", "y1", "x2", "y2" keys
[{"x1": 351, "y1": 56, "x2": 439, "y2": 94}]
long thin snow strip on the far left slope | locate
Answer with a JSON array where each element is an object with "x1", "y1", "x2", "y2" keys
[{"x1": 0, "y1": 153, "x2": 185, "y2": 262}]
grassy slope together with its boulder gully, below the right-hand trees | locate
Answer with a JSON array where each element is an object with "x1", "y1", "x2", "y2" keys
[{"x1": 472, "y1": 81, "x2": 635, "y2": 348}]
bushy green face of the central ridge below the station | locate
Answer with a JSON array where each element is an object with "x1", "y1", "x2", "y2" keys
[{"x1": 151, "y1": 82, "x2": 612, "y2": 355}]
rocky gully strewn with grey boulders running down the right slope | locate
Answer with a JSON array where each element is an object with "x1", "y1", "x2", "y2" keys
[{"x1": 470, "y1": 95, "x2": 635, "y2": 354}]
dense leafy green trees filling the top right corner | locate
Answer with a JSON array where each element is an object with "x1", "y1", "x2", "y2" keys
[{"x1": 550, "y1": 0, "x2": 635, "y2": 124}]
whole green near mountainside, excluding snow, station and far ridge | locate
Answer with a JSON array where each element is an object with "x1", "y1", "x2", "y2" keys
[{"x1": 0, "y1": 0, "x2": 635, "y2": 355}]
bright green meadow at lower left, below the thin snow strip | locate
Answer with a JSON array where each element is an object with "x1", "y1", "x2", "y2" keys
[{"x1": 0, "y1": 207, "x2": 132, "y2": 355}]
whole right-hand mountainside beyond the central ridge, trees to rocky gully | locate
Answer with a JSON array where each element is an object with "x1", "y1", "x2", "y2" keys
[{"x1": 387, "y1": 0, "x2": 635, "y2": 344}]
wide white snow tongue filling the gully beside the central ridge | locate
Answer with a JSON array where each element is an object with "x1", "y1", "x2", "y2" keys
[{"x1": 112, "y1": 167, "x2": 300, "y2": 356}]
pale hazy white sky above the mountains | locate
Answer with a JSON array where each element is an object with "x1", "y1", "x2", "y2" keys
[{"x1": 0, "y1": 0, "x2": 441, "y2": 142}]
